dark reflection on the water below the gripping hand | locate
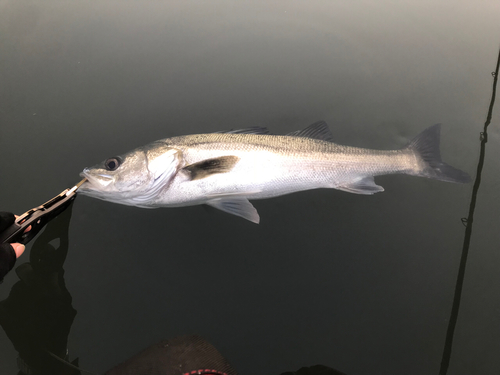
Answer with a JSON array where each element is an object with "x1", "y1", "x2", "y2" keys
[{"x1": 0, "y1": 205, "x2": 79, "y2": 374}]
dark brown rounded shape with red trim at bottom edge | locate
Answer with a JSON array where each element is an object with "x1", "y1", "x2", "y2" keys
[{"x1": 106, "y1": 336, "x2": 238, "y2": 375}]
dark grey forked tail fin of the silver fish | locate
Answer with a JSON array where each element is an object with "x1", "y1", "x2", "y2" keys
[{"x1": 406, "y1": 124, "x2": 471, "y2": 184}]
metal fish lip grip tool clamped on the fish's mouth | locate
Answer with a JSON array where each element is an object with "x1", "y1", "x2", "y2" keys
[{"x1": 0, "y1": 178, "x2": 87, "y2": 245}]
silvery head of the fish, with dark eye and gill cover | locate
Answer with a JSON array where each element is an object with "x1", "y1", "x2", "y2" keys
[{"x1": 78, "y1": 143, "x2": 183, "y2": 207}]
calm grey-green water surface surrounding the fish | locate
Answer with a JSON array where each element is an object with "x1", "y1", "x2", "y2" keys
[{"x1": 0, "y1": 0, "x2": 500, "y2": 375}]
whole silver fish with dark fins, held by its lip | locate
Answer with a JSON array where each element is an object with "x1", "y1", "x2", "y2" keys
[{"x1": 78, "y1": 121, "x2": 471, "y2": 224}]
